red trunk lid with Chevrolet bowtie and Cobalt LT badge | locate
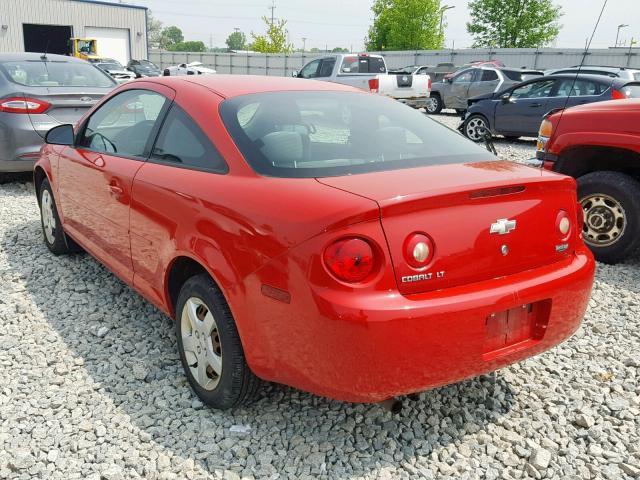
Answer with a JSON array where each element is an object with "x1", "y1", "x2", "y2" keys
[{"x1": 318, "y1": 161, "x2": 577, "y2": 295}]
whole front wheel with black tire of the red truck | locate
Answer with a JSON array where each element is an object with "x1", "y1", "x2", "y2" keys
[{"x1": 578, "y1": 172, "x2": 640, "y2": 263}]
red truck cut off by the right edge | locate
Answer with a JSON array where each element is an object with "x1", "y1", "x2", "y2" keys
[{"x1": 530, "y1": 96, "x2": 640, "y2": 263}]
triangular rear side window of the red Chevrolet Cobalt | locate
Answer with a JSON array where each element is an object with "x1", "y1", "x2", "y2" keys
[{"x1": 151, "y1": 104, "x2": 229, "y2": 173}]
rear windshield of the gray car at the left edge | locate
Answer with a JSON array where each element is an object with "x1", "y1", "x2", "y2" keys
[{"x1": 0, "y1": 60, "x2": 115, "y2": 87}]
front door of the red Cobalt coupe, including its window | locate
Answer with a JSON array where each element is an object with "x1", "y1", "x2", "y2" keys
[{"x1": 58, "y1": 83, "x2": 174, "y2": 283}]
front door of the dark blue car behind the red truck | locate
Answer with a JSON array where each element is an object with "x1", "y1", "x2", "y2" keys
[{"x1": 494, "y1": 78, "x2": 556, "y2": 136}]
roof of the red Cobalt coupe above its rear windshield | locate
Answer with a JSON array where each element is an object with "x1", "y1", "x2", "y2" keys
[{"x1": 145, "y1": 74, "x2": 362, "y2": 98}]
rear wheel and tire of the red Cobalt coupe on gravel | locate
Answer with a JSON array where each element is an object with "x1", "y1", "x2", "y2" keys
[{"x1": 176, "y1": 274, "x2": 262, "y2": 410}]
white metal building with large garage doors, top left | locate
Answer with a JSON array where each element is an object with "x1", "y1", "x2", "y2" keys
[{"x1": 0, "y1": 0, "x2": 147, "y2": 64}]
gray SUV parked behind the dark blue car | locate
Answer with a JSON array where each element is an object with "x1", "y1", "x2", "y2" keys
[{"x1": 425, "y1": 65, "x2": 542, "y2": 114}]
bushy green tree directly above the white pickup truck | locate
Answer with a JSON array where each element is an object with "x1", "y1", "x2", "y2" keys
[{"x1": 365, "y1": 0, "x2": 444, "y2": 51}]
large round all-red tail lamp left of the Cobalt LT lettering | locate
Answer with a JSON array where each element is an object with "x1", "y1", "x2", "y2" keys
[{"x1": 323, "y1": 238, "x2": 375, "y2": 283}]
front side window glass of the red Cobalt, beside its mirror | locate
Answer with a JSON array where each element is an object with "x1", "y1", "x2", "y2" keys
[{"x1": 78, "y1": 90, "x2": 167, "y2": 158}]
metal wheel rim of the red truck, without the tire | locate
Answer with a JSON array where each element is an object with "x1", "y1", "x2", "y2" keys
[{"x1": 580, "y1": 193, "x2": 627, "y2": 247}]
